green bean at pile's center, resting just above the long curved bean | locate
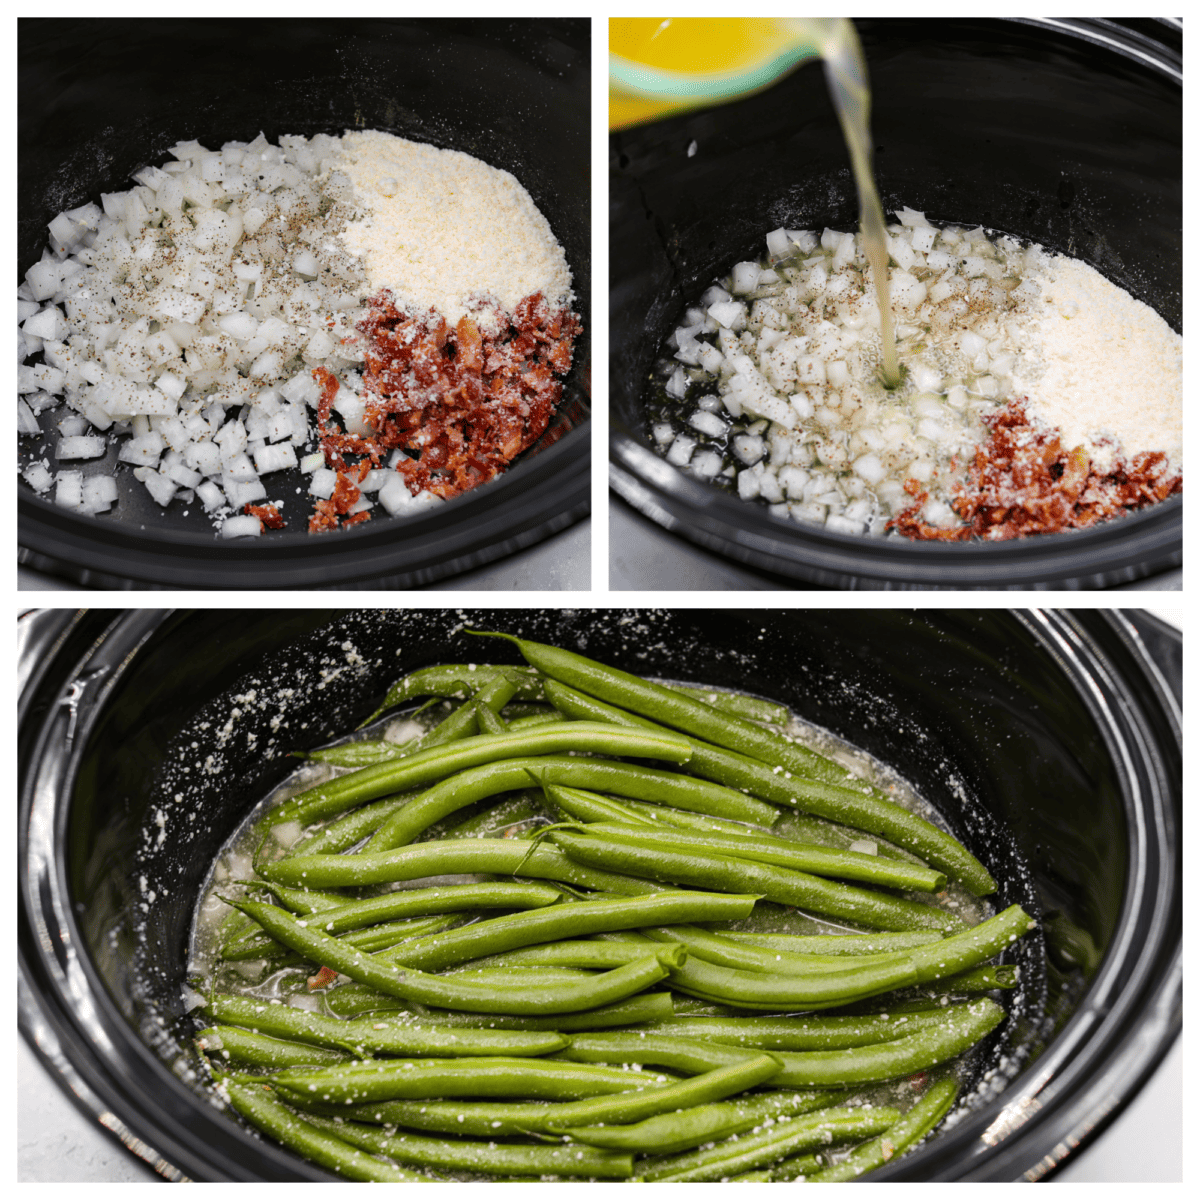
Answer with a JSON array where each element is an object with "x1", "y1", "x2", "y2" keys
[{"x1": 369, "y1": 892, "x2": 757, "y2": 971}]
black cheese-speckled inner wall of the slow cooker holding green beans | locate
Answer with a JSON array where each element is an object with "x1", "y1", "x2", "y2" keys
[{"x1": 67, "y1": 611, "x2": 1124, "y2": 1104}]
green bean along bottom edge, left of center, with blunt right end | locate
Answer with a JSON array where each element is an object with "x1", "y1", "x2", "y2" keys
[{"x1": 302, "y1": 1117, "x2": 634, "y2": 1180}]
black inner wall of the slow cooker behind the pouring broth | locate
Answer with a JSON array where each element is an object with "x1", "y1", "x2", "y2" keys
[{"x1": 611, "y1": 19, "x2": 1183, "y2": 439}]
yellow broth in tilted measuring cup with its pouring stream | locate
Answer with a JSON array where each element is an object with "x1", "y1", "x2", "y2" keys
[{"x1": 608, "y1": 17, "x2": 901, "y2": 386}]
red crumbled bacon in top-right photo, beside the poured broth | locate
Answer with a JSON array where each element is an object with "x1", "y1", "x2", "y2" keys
[{"x1": 889, "y1": 400, "x2": 1183, "y2": 541}]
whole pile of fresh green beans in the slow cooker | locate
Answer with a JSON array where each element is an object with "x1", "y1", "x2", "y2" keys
[{"x1": 192, "y1": 635, "x2": 1033, "y2": 1182}]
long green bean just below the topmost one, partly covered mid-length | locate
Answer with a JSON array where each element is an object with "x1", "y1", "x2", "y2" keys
[{"x1": 546, "y1": 680, "x2": 996, "y2": 896}]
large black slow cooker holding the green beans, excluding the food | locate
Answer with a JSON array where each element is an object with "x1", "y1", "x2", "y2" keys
[{"x1": 18, "y1": 610, "x2": 1182, "y2": 1181}]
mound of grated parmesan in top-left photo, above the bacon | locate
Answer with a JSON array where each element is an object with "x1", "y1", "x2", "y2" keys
[{"x1": 340, "y1": 130, "x2": 572, "y2": 324}]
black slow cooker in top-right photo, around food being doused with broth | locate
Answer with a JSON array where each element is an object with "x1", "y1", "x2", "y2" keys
[{"x1": 610, "y1": 18, "x2": 1183, "y2": 589}]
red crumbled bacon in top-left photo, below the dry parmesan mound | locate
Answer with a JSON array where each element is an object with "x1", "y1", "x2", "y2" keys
[{"x1": 310, "y1": 292, "x2": 580, "y2": 533}]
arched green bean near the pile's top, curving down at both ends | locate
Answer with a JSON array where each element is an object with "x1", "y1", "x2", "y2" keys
[{"x1": 366, "y1": 753, "x2": 776, "y2": 853}]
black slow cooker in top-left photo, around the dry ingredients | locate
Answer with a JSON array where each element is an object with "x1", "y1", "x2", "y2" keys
[{"x1": 17, "y1": 18, "x2": 592, "y2": 588}]
